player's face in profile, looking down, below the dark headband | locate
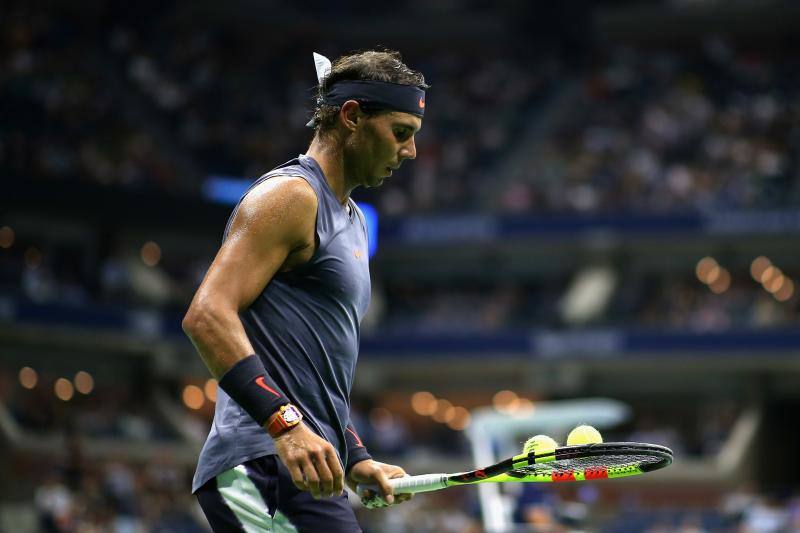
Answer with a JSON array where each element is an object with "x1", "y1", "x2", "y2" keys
[{"x1": 348, "y1": 111, "x2": 422, "y2": 187}]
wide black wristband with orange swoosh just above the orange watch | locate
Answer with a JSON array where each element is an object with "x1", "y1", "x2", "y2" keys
[{"x1": 219, "y1": 354, "x2": 289, "y2": 426}]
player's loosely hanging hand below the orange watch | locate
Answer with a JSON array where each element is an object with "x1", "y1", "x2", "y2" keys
[{"x1": 275, "y1": 422, "x2": 344, "y2": 498}]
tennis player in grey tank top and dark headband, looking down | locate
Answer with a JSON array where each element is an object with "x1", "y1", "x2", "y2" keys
[{"x1": 183, "y1": 51, "x2": 428, "y2": 533}]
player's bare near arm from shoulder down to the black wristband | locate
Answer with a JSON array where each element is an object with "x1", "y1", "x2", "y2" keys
[{"x1": 183, "y1": 177, "x2": 317, "y2": 379}]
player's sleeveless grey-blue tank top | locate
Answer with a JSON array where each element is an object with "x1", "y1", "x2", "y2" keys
[{"x1": 192, "y1": 155, "x2": 370, "y2": 492}]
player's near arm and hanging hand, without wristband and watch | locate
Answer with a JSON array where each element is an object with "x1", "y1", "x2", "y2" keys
[{"x1": 183, "y1": 177, "x2": 344, "y2": 497}]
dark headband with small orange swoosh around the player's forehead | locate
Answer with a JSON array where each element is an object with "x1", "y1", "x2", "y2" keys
[{"x1": 322, "y1": 80, "x2": 425, "y2": 118}]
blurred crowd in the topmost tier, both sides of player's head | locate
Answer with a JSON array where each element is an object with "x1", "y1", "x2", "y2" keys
[{"x1": 7, "y1": 5, "x2": 800, "y2": 215}]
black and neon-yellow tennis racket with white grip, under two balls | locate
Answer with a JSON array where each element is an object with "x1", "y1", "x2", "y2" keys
[{"x1": 357, "y1": 442, "x2": 672, "y2": 500}]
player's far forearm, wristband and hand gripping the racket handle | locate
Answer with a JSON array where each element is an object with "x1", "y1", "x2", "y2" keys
[{"x1": 345, "y1": 422, "x2": 413, "y2": 508}]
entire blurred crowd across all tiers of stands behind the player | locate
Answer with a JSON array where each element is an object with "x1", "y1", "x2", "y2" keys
[{"x1": 0, "y1": 1, "x2": 800, "y2": 533}]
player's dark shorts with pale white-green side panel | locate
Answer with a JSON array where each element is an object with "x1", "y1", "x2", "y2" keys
[{"x1": 195, "y1": 455, "x2": 361, "y2": 533}]
